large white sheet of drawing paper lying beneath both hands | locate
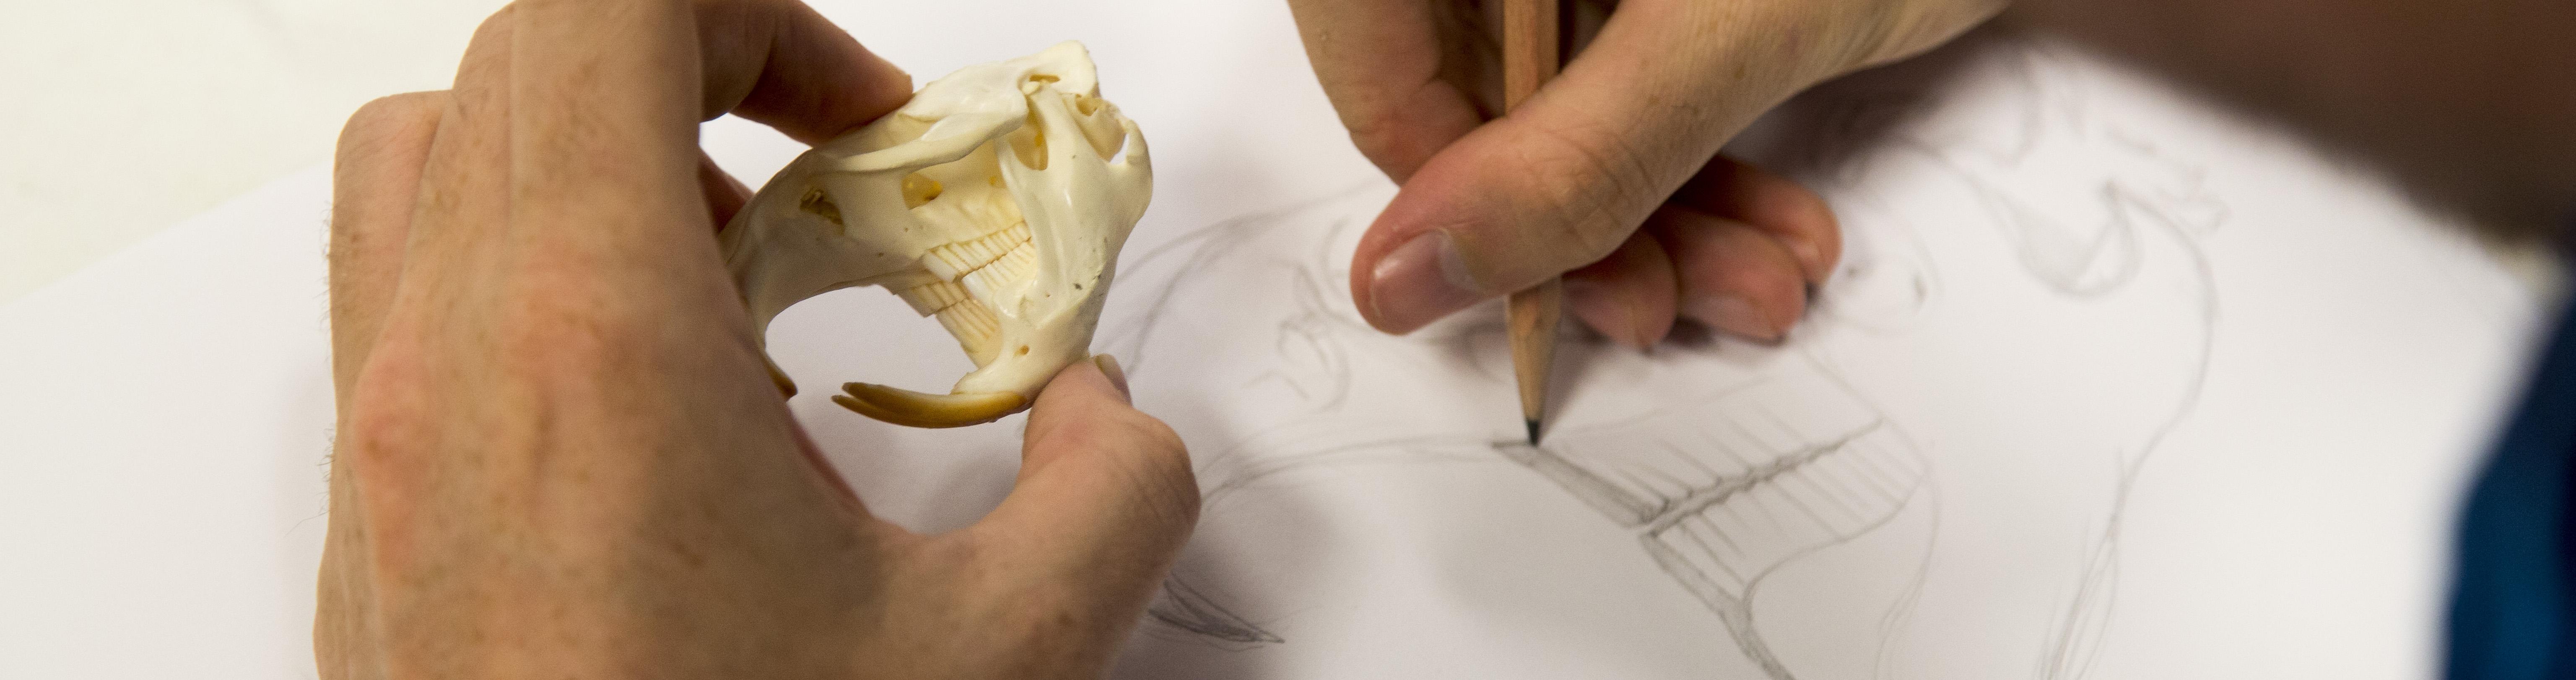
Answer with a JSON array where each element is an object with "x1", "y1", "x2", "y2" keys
[{"x1": 0, "y1": 10, "x2": 2537, "y2": 680}]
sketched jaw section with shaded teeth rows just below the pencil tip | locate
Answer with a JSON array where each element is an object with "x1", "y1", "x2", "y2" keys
[{"x1": 1494, "y1": 381, "x2": 1924, "y2": 677}]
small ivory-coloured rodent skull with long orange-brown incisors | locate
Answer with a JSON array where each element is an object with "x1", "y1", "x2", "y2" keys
[{"x1": 719, "y1": 41, "x2": 1154, "y2": 427}]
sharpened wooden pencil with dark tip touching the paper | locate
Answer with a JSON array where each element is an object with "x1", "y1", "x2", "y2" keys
[{"x1": 1502, "y1": 0, "x2": 1566, "y2": 446}]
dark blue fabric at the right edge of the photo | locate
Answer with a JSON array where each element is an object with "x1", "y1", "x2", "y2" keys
[{"x1": 2445, "y1": 302, "x2": 2576, "y2": 680}]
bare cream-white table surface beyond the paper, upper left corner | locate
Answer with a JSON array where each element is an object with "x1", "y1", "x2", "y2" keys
[{"x1": 0, "y1": 0, "x2": 502, "y2": 301}]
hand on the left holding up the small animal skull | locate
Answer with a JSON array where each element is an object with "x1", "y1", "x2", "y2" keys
[{"x1": 314, "y1": 0, "x2": 1198, "y2": 677}]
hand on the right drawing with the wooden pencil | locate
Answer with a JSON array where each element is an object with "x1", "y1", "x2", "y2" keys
[{"x1": 1288, "y1": 0, "x2": 2007, "y2": 348}]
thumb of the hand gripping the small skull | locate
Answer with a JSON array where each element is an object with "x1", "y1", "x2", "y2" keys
[{"x1": 974, "y1": 355, "x2": 1198, "y2": 600}]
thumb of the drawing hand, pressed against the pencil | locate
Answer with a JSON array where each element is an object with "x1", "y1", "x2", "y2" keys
[{"x1": 1350, "y1": 3, "x2": 1849, "y2": 332}]
